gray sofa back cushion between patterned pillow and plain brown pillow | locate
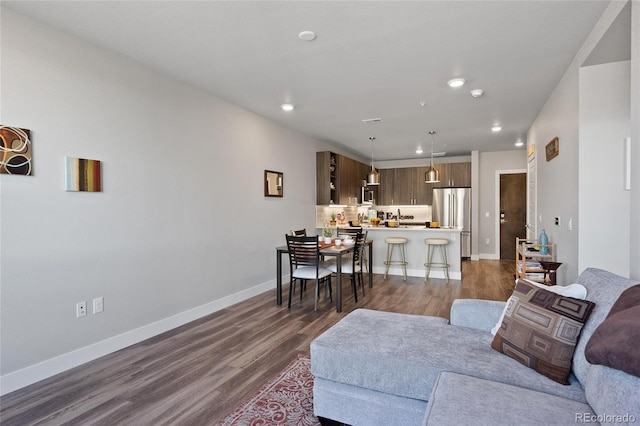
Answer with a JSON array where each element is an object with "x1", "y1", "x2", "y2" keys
[{"x1": 572, "y1": 268, "x2": 640, "y2": 387}]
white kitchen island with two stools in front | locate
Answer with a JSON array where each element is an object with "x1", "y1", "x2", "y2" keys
[{"x1": 317, "y1": 225, "x2": 462, "y2": 280}]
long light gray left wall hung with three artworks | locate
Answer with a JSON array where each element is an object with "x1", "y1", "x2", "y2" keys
[{"x1": 0, "y1": 9, "x2": 326, "y2": 393}]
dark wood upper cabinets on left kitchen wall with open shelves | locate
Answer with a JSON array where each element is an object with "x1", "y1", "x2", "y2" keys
[{"x1": 316, "y1": 151, "x2": 369, "y2": 205}]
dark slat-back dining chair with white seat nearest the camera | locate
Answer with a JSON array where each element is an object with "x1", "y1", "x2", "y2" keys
[{"x1": 285, "y1": 235, "x2": 333, "y2": 311}]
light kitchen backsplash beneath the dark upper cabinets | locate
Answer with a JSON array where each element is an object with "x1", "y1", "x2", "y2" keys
[{"x1": 316, "y1": 205, "x2": 431, "y2": 228}]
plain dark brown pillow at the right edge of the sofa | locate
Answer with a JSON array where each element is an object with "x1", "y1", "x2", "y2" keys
[{"x1": 585, "y1": 285, "x2": 640, "y2": 377}]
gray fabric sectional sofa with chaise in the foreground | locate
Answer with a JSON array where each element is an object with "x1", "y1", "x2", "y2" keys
[{"x1": 311, "y1": 268, "x2": 640, "y2": 426}]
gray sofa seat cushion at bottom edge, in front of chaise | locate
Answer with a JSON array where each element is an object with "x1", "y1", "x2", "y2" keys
[{"x1": 422, "y1": 372, "x2": 594, "y2": 426}]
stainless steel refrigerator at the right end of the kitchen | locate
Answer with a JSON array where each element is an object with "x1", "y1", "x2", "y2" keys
[{"x1": 431, "y1": 187, "x2": 471, "y2": 257}]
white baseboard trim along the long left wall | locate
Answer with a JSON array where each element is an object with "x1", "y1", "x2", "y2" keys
[{"x1": 0, "y1": 275, "x2": 276, "y2": 395}]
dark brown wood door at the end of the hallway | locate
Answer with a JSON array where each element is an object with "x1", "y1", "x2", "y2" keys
[{"x1": 500, "y1": 173, "x2": 527, "y2": 259}]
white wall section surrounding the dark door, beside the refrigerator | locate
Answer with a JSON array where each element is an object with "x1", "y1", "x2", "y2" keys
[{"x1": 475, "y1": 149, "x2": 527, "y2": 259}]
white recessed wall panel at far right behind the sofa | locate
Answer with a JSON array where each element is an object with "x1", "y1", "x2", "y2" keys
[{"x1": 578, "y1": 61, "x2": 631, "y2": 276}]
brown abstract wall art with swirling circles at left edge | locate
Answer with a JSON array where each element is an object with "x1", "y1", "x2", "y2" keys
[{"x1": 0, "y1": 124, "x2": 32, "y2": 176}]
